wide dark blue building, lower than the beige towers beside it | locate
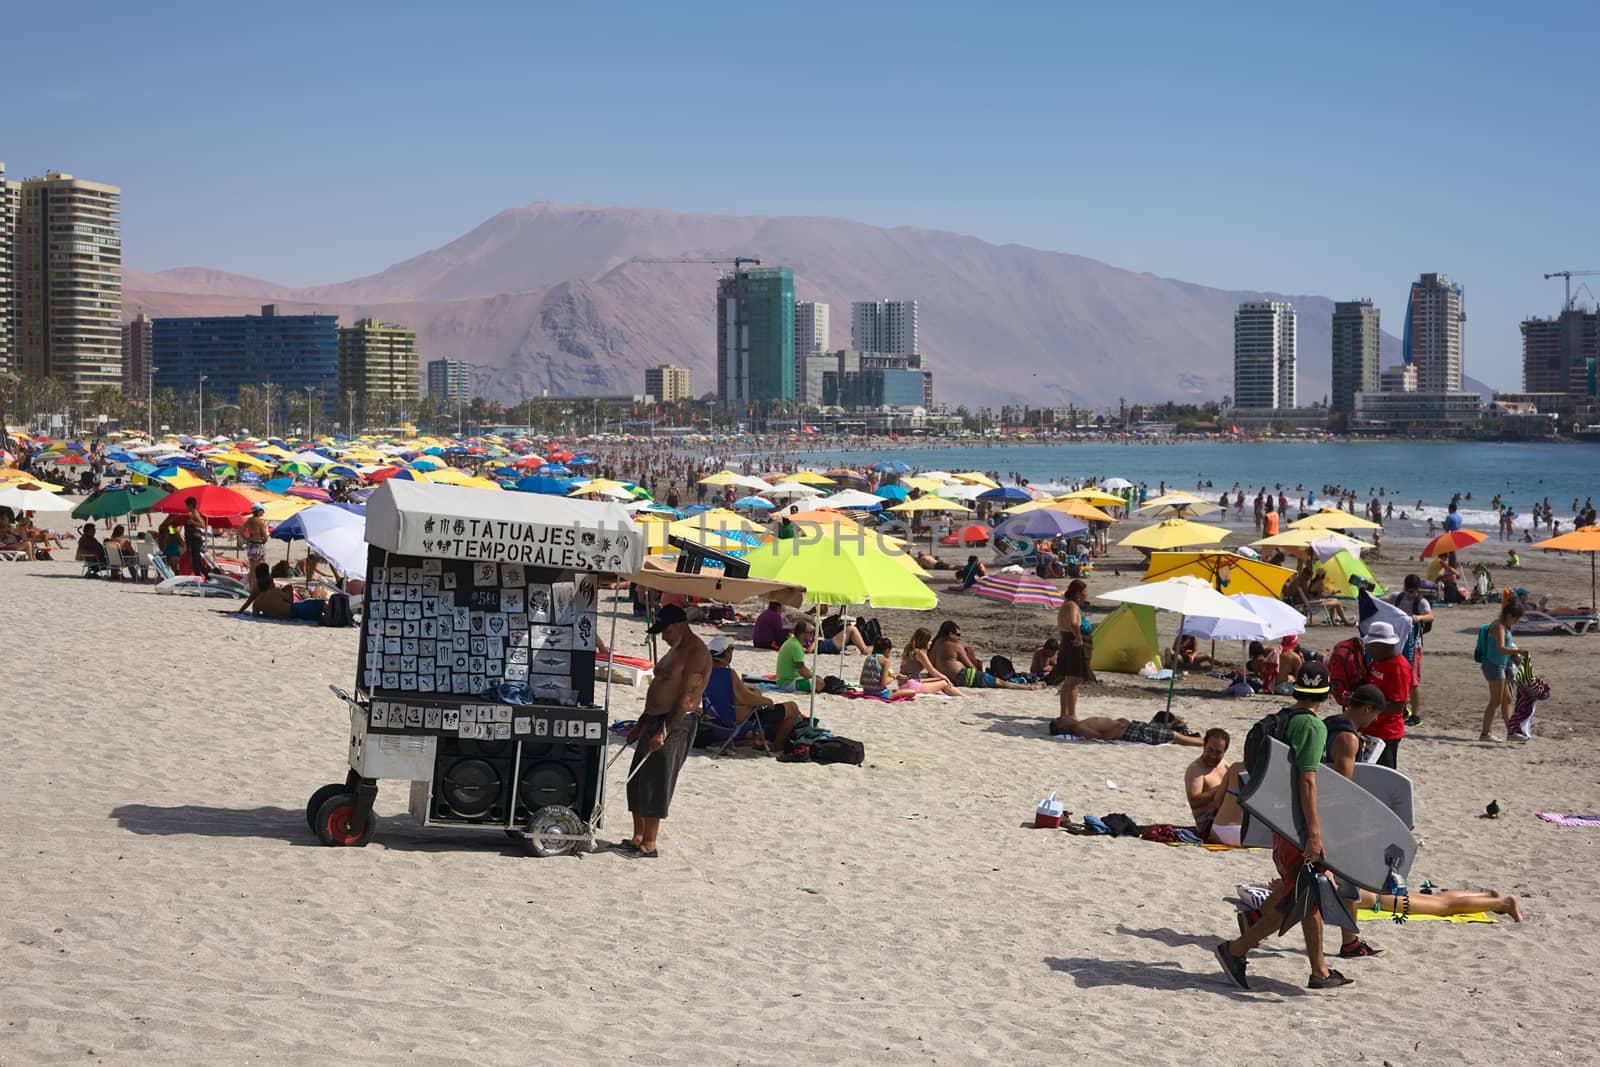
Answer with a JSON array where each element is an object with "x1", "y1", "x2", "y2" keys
[{"x1": 150, "y1": 304, "x2": 339, "y2": 429}]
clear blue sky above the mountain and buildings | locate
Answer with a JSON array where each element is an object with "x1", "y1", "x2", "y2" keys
[{"x1": 0, "y1": 2, "x2": 1600, "y2": 387}]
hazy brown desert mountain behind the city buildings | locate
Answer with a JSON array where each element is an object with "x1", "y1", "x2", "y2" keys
[{"x1": 123, "y1": 203, "x2": 1398, "y2": 406}]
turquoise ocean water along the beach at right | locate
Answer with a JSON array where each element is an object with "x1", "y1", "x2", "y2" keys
[{"x1": 800, "y1": 442, "x2": 1600, "y2": 533}]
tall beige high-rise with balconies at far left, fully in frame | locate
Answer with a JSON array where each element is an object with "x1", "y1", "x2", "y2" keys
[{"x1": 13, "y1": 171, "x2": 122, "y2": 400}]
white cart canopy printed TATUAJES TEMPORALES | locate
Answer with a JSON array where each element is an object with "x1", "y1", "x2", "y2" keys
[{"x1": 366, "y1": 478, "x2": 645, "y2": 574}]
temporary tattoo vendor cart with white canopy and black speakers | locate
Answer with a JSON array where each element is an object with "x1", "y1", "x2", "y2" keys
[{"x1": 306, "y1": 478, "x2": 645, "y2": 856}]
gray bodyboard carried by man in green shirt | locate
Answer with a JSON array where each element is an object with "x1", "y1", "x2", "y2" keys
[{"x1": 1238, "y1": 737, "x2": 1416, "y2": 893}]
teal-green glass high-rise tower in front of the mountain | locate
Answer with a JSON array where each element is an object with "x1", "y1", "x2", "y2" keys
[{"x1": 717, "y1": 267, "x2": 795, "y2": 411}]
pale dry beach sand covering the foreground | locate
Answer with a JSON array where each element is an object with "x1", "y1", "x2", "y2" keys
[{"x1": 0, "y1": 531, "x2": 1600, "y2": 1064}]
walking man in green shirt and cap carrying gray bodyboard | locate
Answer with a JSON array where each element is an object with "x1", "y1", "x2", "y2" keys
[{"x1": 1216, "y1": 661, "x2": 1355, "y2": 989}]
